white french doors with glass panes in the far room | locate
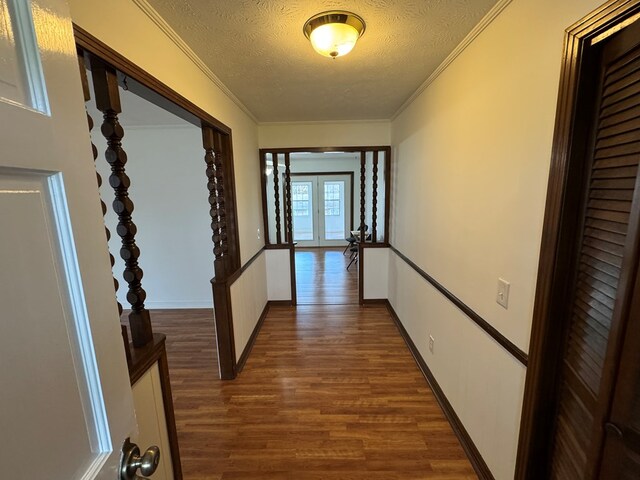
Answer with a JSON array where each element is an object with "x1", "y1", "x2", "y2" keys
[{"x1": 291, "y1": 174, "x2": 353, "y2": 247}]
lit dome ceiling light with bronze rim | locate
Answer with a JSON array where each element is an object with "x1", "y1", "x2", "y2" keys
[{"x1": 303, "y1": 10, "x2": 365, "y2": 58}]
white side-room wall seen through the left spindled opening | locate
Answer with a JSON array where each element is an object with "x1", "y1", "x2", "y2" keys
[{"x1": 92, "y1": 125, "x2": 214, "y2": 308}]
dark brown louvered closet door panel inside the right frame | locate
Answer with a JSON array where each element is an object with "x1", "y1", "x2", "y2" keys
[{"x1": 551, "y1": 19, "x2": 640, "y2": 480}]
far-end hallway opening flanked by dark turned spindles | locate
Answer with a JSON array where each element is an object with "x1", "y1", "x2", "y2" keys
[{"x1": 260, "y1": 146, "x2": 391, "y2": 305}]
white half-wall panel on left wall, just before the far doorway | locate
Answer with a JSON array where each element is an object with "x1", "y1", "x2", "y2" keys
[{"x1": 231, "y1": 251, "x2": 267, "y2": 360}]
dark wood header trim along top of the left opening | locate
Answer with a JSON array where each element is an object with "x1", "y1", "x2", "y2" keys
[{"x1": 73, "y1": 24, "x2": 231, "y2": 134}]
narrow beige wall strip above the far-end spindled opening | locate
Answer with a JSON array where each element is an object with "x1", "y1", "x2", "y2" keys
[{"x1": 258, "y1": 121, "x2": 391, "y2": 148}]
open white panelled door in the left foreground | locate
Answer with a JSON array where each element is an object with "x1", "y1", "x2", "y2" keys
[{"x1": 0, "y1": 0, "x2": 135, "y2": 480}]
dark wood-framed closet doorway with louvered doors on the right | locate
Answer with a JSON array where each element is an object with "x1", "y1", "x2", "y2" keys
[{"x1": 516, "y1": 2, "x2": 640, "y2": 479}]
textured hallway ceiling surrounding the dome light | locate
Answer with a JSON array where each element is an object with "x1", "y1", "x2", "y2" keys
[{"x1": 148, "y1": 0, "x2": 496, "y2": 122}]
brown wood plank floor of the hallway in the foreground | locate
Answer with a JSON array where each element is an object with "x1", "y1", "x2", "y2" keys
[{"x1": 152, "y1": 305, "x2": 476, "y2": 480}]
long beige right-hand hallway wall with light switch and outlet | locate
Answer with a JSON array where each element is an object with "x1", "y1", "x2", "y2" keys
[{"x1": 390, "y1": 0, "x2": 601, "y2": 479}]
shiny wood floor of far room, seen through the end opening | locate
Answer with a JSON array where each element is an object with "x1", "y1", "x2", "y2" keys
[{"x1": 296, "y1": 248, "x2": 358, "y2": 305}]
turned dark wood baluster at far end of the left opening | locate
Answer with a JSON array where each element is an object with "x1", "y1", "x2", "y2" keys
[{"x1": 202, "y1": 126, "x2": 229, "y2": 281}]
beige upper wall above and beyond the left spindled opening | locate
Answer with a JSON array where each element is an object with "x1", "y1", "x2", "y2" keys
[{"x1": 68, "y1": 0, "x2": 263, "y2": 264}]
